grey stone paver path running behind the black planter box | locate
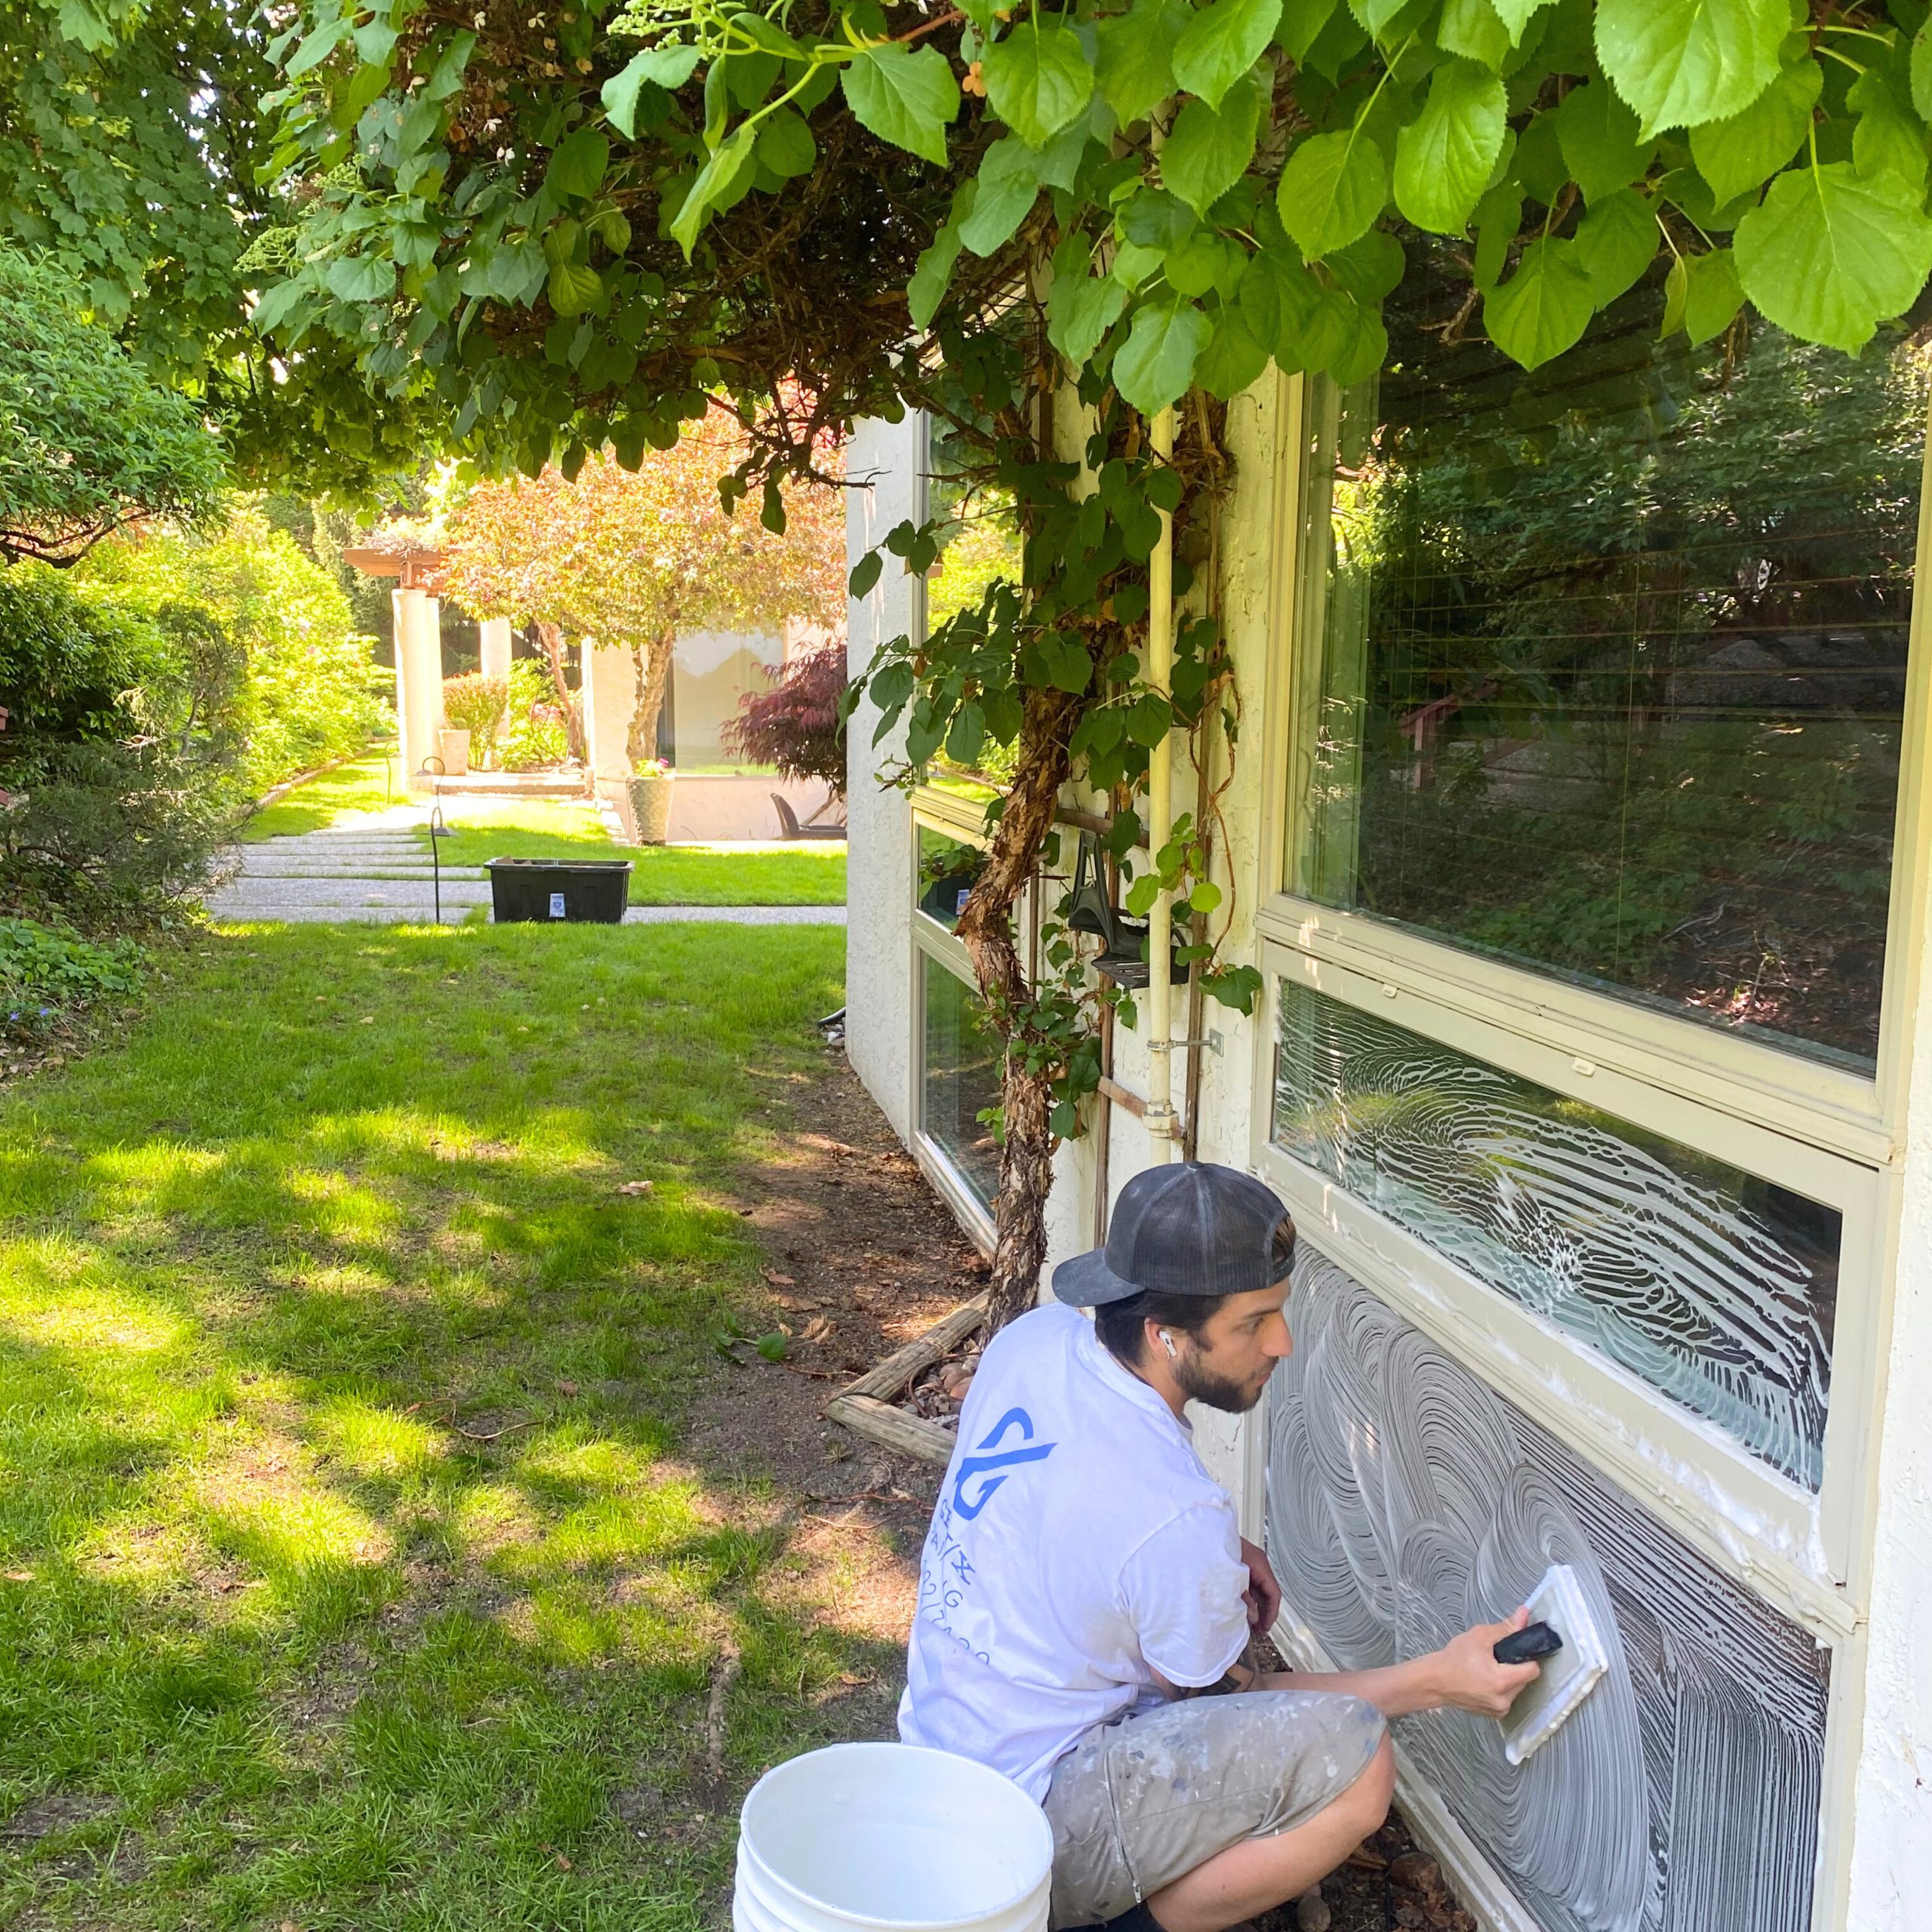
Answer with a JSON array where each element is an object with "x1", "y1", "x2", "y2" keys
[{"x1": 207, "y1": 804, "x2": 846, "y2": 925}]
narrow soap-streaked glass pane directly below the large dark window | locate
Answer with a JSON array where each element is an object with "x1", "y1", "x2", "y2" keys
[{"x1": 1273, "y1": 981, "x2": 1841, "y2": 1490}]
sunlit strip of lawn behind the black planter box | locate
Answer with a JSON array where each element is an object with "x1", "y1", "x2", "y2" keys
[{"x1": 423, "y1": 798, "x2": 846, "y2": 906}]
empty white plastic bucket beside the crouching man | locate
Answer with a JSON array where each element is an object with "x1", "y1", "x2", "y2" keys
[{"x1": 732, "y1": 1745, "x2": 1053, "y2": 1932}]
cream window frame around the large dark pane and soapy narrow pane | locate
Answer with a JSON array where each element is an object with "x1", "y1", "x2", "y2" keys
[{"x1": 1250, "y1": 363, "x2": 1932, "y2": 1630}]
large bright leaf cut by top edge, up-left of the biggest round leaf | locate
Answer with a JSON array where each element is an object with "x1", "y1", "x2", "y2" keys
[{"x1": 1596, "y1": 0, "x2": 1791, "y2": 139}]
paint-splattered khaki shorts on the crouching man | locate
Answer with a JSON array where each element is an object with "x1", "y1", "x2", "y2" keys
[{"x1": 1045, "y1": 1690, "x2": 1383, "y2": 1928}]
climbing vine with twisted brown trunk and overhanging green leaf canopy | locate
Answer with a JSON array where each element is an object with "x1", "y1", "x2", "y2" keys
[{"x1": 261, "y1": 0, "x2": 1932, "y2": 1312}]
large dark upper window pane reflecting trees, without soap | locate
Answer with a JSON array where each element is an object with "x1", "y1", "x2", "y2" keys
[{"x1": 1291, "y1": 238, "x2": 1926, "y2": 1066}]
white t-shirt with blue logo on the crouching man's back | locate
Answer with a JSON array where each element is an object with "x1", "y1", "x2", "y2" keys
[{"x1": 898, "y1": 1306, "x2": 1248, "y2": 1798}]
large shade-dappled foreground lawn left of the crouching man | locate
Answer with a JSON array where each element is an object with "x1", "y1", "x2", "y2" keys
[{"x1": 0, "y1": 925, "x2": 889, "y2": 1932}]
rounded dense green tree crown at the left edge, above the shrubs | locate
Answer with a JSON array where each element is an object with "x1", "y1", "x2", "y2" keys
[{"x1": 0, "y1": 249, "x2": 224, "y2": 566}]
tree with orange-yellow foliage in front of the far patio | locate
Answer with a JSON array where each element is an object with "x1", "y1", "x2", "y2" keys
[{"x1": 442, "y1": 411, "x2": 844, "y2": 761}]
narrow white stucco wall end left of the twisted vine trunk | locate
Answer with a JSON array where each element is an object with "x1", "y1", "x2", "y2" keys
[{"x1": 846, "y1": 414, "x2": 925, "y2": 1142}]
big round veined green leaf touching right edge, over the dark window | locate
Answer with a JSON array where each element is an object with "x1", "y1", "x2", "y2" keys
[{"x1": 1735, "y1": 160, "x2": 1932, "y2": 349}]
